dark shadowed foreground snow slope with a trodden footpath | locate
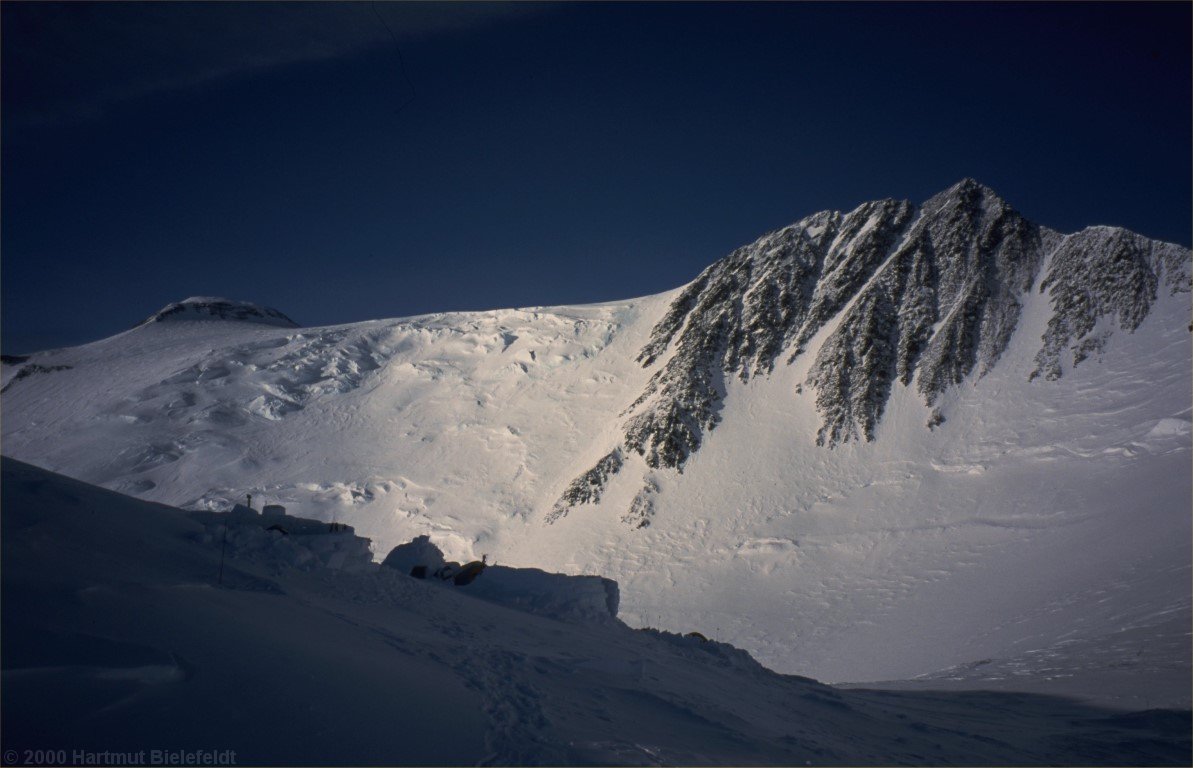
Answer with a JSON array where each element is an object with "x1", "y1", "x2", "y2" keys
[{"x1": 0, "y1": 458, "x2": 1191, "y2": 766}]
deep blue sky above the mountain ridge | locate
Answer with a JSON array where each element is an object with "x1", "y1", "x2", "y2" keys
[{"x1": 0, "y1": 1, "x2": 1193, "y2": 353}]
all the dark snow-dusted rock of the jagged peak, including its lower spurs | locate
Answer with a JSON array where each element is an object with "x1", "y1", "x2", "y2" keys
[{"x1": 549, "y1": 179, "x2": 1189, "y2": 527}]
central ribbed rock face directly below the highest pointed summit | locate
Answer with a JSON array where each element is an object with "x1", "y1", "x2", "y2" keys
[{"x1": 808, "y1": 181, "x2": 1058, "y2": 447}]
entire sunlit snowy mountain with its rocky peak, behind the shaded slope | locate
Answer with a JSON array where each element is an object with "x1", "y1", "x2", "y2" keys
[{"x1": 2, "y1": 180, "x2": 1193, "y2": 706}]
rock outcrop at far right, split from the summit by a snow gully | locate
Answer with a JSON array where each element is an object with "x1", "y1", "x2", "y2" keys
[{"x1": 1031, "y1": 227, "x2": 1189, "y2": 380}]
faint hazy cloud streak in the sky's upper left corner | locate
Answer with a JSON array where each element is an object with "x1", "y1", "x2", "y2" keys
[{"x1": 2, "y1": 2, "x2": 544, "y2": 123}]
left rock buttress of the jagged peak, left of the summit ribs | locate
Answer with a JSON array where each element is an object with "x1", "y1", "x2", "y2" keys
[{"x1": 625, "y1": 200, "x2": 914, "y2": 470}]
